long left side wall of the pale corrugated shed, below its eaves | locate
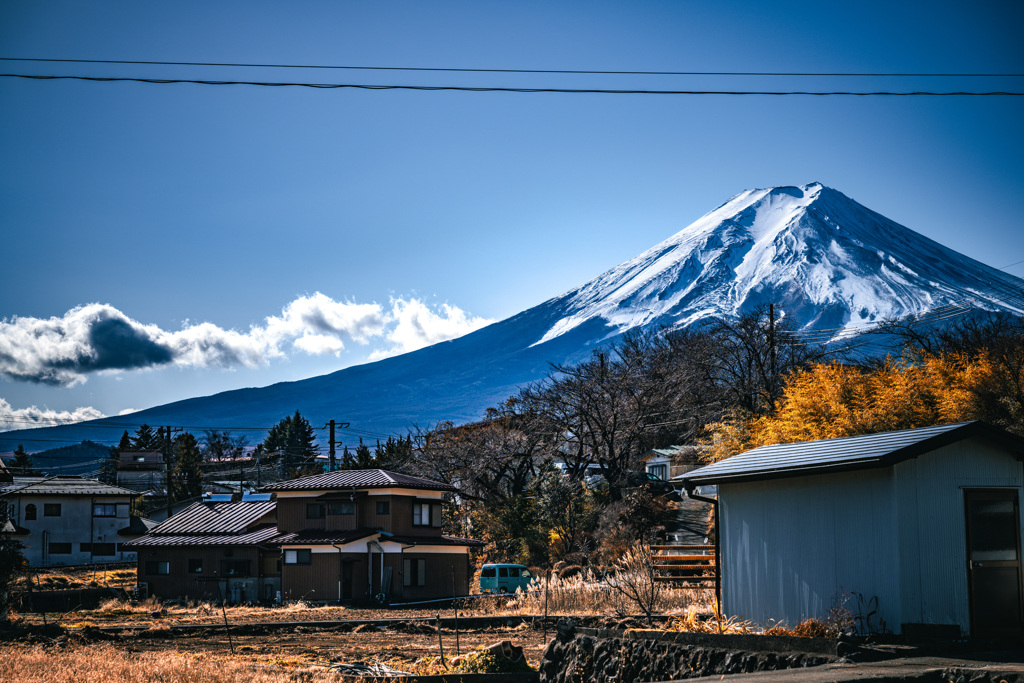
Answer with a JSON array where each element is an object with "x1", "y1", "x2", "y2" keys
[{"x1": 719, "y1": 470, "x2": 899, "y2": 627}]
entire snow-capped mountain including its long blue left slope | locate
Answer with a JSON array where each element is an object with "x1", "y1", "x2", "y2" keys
[{"x1": 8, "y1": 183, "x2": 1024, "y2": 450}]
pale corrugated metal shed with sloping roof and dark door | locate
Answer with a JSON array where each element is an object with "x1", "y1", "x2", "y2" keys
[{"x1": 682, "y1": 422, "x2": 1024, "y2": 636}]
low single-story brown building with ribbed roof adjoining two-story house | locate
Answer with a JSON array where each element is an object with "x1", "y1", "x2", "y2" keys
[{"x1": 127, "y1": 501, "x2": 281, "y2": 603}]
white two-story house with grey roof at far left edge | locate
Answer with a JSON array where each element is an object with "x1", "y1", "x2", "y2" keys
[{"x1": 0, "y1": 476, "x2": 145, "y2": 566}]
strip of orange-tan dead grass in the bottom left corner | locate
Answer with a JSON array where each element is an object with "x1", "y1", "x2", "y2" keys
[{"x1": 0, "y1": 644, "x2": 341, "y2": 683}]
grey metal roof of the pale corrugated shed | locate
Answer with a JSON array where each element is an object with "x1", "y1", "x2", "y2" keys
[{"x1": 678, "y1": 422, "x2": 1024, "y2": 490}]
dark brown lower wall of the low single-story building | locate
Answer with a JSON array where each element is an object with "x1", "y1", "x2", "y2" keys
[{"x1": 138, "y1": 547, "x2": 276, "y2": 601}]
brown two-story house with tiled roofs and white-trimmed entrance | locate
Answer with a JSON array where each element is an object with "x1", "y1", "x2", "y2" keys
[{"x1": 263, "y1": 470, "x2": 482, "y2": 602}]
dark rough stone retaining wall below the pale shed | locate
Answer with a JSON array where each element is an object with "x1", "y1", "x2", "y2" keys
[{"x1": 541, "y1": 621, "x2": 838, "y2": 683}]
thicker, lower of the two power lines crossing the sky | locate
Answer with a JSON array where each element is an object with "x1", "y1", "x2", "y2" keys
[{"x1": 0, "y1": 74, "x2": 1024, "y2": 97}]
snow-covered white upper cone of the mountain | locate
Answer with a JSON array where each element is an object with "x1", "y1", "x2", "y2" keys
[{"x1": 537, "y1": 182, "x2": 1024, "y2": 343}]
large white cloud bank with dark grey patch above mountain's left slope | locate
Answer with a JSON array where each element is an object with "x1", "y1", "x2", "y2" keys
[{"x1": 0, "y1": 292, "x2": 493, "y2": 387}]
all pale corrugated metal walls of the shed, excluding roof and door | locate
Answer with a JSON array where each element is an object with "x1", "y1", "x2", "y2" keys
[{"x1": 719, "y1": 439, "x2": 1024, "y2": 633}]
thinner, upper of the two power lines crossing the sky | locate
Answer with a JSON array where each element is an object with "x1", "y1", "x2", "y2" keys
[{"x1": 0, "y1": 57, "x2": 1024, "y2": 78}]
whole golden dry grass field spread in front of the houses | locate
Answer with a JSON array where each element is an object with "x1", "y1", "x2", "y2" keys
[{"x1": 0, "y1": 571, "x2": 711, "y2": 683}]
